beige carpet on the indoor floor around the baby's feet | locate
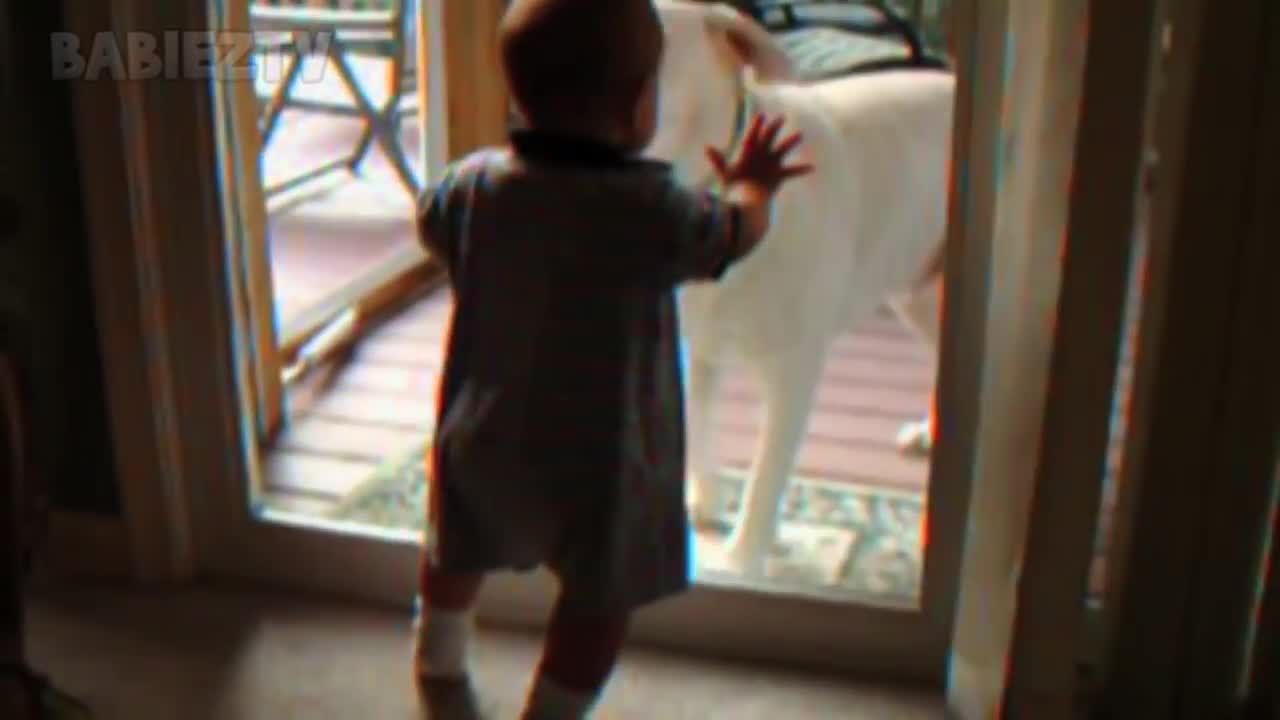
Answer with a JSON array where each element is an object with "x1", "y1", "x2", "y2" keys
[{"x1": 17, "y1": 579, "x2": 942, "y2": 720}]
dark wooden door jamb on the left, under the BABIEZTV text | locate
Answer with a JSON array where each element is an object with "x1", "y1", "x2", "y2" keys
[{"x1": 54, "y1": 3, "x2": 209, "y2": 582}]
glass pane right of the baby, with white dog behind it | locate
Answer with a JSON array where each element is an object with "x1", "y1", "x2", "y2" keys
[{"x1": 652, "y1": 3, "x2": 952, "y2": 606}]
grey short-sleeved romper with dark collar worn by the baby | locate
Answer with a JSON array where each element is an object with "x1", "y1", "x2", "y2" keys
[{"x1": 419, "y1": 131, "x2": 745, "y2": 611}]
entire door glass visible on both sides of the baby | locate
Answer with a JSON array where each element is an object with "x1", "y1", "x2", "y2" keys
[{"x1": 220, "y1": 0, "x2": 993, "y2": 607}]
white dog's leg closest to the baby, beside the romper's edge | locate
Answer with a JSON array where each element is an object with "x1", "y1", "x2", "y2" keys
[{"x1": 686, "y1": 355, "x2": 726, "y2": 529}]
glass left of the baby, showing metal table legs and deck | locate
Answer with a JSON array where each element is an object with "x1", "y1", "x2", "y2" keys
[{"x1": 220, "y1": 0, "x2": 439, "y2": 520}]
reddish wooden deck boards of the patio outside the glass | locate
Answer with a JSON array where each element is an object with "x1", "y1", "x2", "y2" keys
[{"x1": 264, "y1": 292, "x2": 934, "y2": 501}]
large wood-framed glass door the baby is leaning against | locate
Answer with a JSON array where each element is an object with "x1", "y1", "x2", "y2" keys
[{"x1": 167, "y1": 0, "x2": 1141, "y2": 680}]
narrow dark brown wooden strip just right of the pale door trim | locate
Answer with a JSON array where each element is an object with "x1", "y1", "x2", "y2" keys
[{"x1": 1004, "y1": 0, "x2": 1162, "y2": 717}]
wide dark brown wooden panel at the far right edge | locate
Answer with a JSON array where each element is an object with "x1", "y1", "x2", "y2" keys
[{"x1": 1097, "y1": 0, "x2": 1280, "y2": 707}]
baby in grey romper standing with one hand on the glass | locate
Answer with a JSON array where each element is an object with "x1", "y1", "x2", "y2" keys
[{"x1": 415, "y1": 0, "x2": 810, "y2": 720}]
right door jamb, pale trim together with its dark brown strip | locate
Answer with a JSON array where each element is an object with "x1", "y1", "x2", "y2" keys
[{"x1": 940, "y1": 0, "x2": 1157, "y2": 719}]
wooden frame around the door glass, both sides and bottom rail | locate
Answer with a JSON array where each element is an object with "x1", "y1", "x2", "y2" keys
[{"x1": 64, "y1": 0, "x2": 1146, "y2": 683}]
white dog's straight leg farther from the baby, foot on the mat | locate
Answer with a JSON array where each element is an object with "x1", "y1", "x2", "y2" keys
[{"x1": 724, "y1": 342, "x2": 827, "y2": 578}]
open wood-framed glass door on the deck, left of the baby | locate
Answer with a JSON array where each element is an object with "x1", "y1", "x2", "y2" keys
[{"x1": 215, "y1": 0, "x2": 440, "y2": 443}]
